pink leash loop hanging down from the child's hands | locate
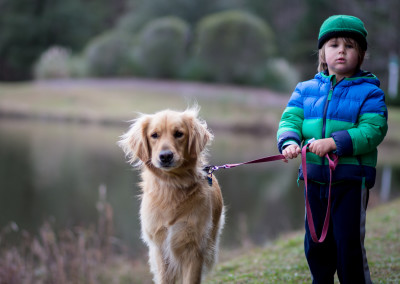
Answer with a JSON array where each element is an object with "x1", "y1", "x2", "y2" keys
[{"x1": 301, "y1": 143, "x2": 339, "y2": 243}]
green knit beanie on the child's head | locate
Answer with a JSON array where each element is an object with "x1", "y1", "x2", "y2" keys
[{"x1": 318, "y1": 15, "x2": 368, "y2": 50}]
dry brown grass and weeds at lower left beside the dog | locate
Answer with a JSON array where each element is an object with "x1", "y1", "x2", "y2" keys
[{"x1": 0, "y1": 186, "x2": 151, "y2": 284}]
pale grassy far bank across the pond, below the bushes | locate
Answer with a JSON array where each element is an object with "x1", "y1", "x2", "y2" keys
[{"x1": 0, "y1": 79, "x2": 400, "y2": 164}]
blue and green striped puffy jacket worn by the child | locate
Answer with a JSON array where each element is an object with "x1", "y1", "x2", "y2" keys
[{"x1": 277, "y1": 71, "x2": 387, "y2": 188}]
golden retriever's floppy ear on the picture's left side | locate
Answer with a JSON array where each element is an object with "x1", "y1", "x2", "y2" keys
[{"x1": 118, "y1": 115, "x2": 151, "y2": 164}]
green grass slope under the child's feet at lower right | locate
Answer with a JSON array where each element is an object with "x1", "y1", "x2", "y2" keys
[{"x1": 205, "y1": 199, "x2": 400, "y2": 284}]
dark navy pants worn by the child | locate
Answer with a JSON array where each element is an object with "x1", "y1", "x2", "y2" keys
[{"x1": 304, "y1": 181, "x2": 372, "y2": 284}]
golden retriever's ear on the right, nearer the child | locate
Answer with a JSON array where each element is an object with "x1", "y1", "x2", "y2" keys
[{"x1": 184, "y1": 109, "x2": 214, "y2": 158}]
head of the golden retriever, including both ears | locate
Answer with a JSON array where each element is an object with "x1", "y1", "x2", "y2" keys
[{"x1": 118, "y1": 107, "x2": 213, "y2": 171}]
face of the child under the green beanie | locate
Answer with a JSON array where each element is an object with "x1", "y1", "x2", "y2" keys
[{"x1": 323, "y1": 38, "x2": 359, "y2": 80}]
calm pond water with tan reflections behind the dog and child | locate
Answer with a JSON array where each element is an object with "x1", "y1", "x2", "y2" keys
[{"x1": 0, "y1": 119, "x2": 400, "y2": 252}]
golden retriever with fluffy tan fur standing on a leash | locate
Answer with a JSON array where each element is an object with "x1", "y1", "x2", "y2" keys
[{"x1": 118, "y1": 107, "x2": 225, "y2": 284}]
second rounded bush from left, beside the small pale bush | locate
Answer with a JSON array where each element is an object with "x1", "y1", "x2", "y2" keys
[{"x1": 84, "y1": 31, "x2": 135, "y2": 77}]
